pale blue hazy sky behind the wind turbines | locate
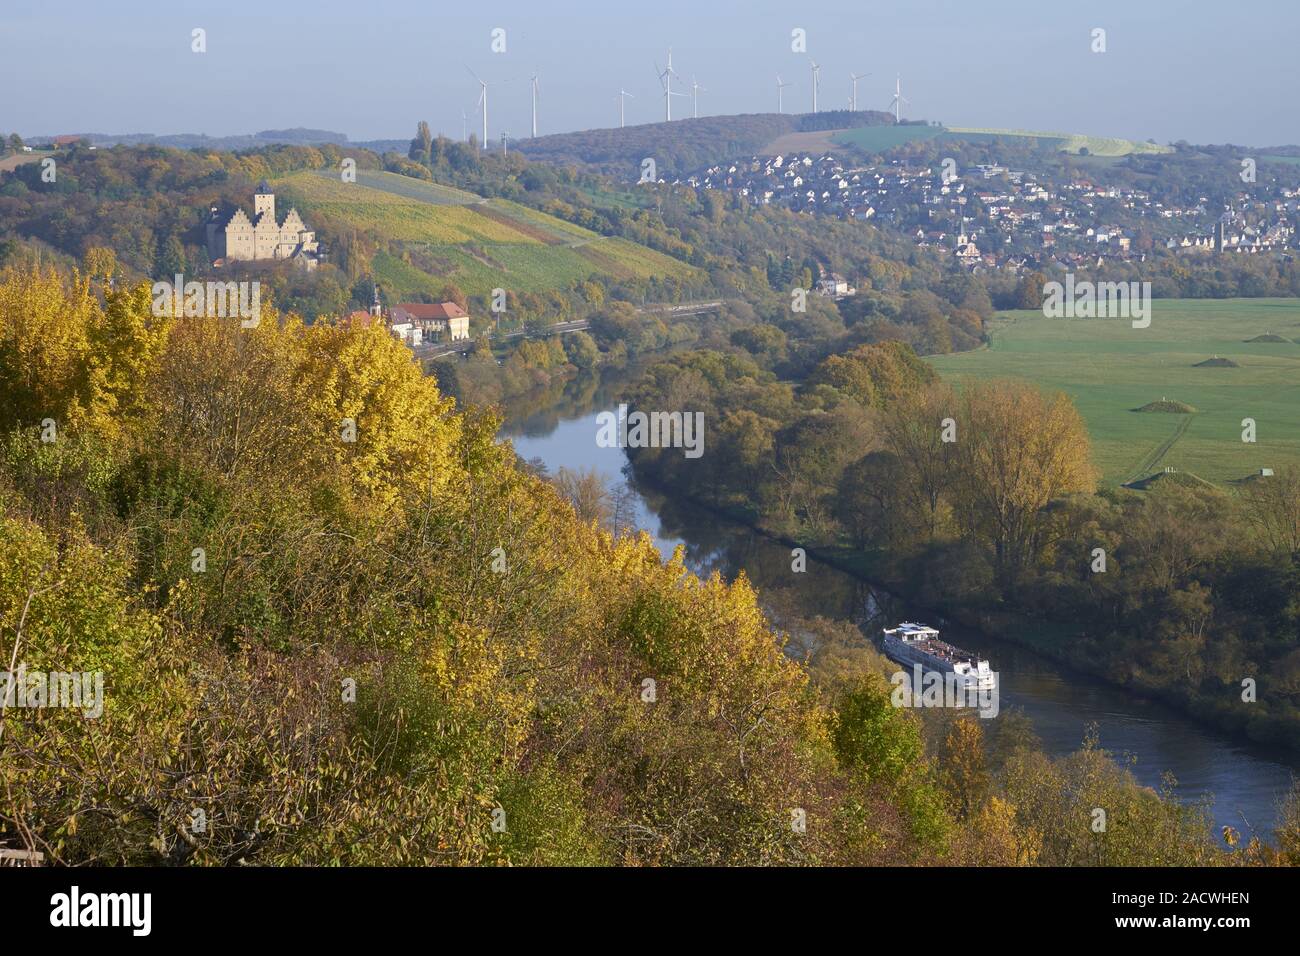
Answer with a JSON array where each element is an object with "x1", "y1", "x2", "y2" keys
[{"x1": 0, "y1": 0, "x2": 1300, "y2": 146}]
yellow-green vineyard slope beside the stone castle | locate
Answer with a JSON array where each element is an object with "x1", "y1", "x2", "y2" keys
[{"x1": 277, "y1": 170, "x2": 693, "y2": 298}]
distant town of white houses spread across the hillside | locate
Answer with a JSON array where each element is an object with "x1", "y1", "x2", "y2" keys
[{"x1": 677, "y1": 153, "x2": 1300, "y2": 271}]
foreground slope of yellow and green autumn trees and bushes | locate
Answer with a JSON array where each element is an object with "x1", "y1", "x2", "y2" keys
[{"x1": 0, "y1": 260, "x2": 1300, "y2": 865}]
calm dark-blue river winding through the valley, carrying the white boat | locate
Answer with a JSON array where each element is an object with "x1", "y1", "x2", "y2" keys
[{"x1": 502, "y1": 373, "x2": 1300, "y2": 842}]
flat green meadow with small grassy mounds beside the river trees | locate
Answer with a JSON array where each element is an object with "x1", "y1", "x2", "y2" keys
[{"x1": 928, "y1": 299, "x2": 1300, "y2": 484}]
